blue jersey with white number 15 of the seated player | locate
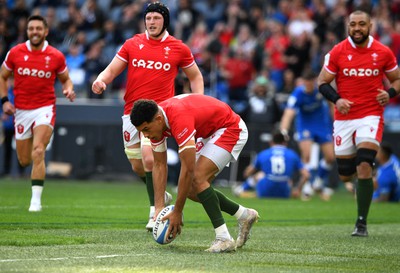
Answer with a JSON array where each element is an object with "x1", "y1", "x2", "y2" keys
[{"x1": 254, "y1": 145, "x2": 303, "y2": 198}]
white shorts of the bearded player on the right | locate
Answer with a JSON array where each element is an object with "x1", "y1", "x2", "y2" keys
[{"x1": 333, "y1": 116, "x2": 383, "y2": 155}]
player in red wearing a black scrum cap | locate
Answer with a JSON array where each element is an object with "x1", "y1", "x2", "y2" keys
[{"x1": 92, "y1": 2, "x2": 204, "y2": 231}]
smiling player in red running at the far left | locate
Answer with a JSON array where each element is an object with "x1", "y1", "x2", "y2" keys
[{"x1": 0, "y1": 15, "x2": 76, "y2": 212}]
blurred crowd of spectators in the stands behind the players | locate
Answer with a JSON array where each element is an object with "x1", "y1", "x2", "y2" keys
[{"x1": 0, "y1": 0, "x2": 400, "y2": 123}]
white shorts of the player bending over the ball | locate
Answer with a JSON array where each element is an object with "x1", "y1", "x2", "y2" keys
[{"x1": 196, "y1": 117, "x2": 248, "y2": 172}]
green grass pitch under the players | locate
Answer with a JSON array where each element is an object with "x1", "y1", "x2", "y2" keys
[{"x1": 0, "y1": 179, "x2": 400, "y2": 273}]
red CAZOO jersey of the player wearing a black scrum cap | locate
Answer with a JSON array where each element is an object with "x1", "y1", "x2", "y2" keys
[{"x1": 116, "y1": 32, "x2": 194, "y2": 115}]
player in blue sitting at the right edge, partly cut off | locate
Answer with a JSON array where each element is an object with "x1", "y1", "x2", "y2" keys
[{"x1": 372, "y1": 142, "x2": 400, "y2": 202}]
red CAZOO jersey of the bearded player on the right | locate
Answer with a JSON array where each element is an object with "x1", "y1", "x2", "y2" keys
[{"x1": 324, "y1": 36, "x2": 398, "y2": 120}]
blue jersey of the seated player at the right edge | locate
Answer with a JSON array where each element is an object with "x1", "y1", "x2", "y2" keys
[{"x1": 373, "y1": 155, "x2": 400, "y2": 202}]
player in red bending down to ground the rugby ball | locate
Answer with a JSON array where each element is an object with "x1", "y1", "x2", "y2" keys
[{"x1": 131, "y1": 94, "x2": 258, "y2": 253}]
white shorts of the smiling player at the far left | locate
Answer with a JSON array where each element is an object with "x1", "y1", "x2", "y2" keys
[{"x1": 14, "y1": 105, "x2": 56, "y2": 140}]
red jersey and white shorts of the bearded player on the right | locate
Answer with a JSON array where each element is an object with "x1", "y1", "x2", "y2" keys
[{"x1": 324, "y1": 36, "x2": 398, "y2": 155}]
